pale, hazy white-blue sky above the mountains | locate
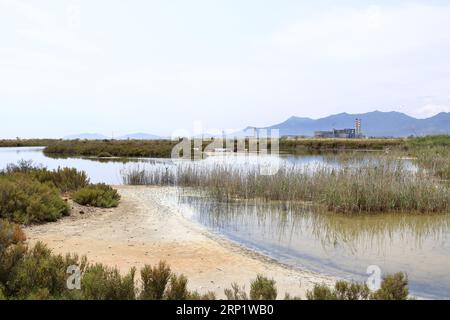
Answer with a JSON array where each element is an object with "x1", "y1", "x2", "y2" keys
[{"x1": 0, "y1": 0, "x2": 450, "y2": 138}]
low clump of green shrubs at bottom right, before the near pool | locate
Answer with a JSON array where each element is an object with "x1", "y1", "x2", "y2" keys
[{"x1": 306, "y1": 273, "x2": 409, "y2": 300}]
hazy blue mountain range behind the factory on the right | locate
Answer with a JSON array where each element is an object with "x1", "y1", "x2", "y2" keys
[{"x1": 253, "y1": 111, "x2": 450, "y2": 137}]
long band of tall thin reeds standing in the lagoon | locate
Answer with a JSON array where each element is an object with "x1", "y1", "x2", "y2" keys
[{"x1": 124, "y1": 158, "x2": 450, "y2": 213}]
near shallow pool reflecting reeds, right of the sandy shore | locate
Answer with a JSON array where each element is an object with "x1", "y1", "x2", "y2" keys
[{"x1": 173, "y1": 192, "x2": 450, "y2": 298}]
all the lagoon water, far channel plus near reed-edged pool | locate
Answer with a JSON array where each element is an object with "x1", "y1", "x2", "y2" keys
[{"x1": 0, "y1": 147, "x2": 450, "y2": 299}]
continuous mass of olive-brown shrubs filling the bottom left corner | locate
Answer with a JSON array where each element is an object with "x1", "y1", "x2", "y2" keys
[{"x1": 0, "y1": 220, "x2": 215, "y2": 300}]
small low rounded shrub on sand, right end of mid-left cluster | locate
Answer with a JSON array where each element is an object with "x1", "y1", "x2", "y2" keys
[{"x1": 73, "y1": 184, "x2": 120, "y2": 208}]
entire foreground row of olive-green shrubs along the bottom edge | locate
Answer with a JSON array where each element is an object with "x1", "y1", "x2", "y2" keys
[{"x1": 0, "y1": 220, "x2": 409, "y2": 300}]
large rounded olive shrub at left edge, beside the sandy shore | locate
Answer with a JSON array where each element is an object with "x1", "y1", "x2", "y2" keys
[{"x1": 0, "y1": 174, "x2": 69, "y2": 224}]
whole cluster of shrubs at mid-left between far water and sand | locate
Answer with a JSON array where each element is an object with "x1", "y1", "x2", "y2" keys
[{"x1": 0, "y1": 161, "x2": 120, "y2": 224}]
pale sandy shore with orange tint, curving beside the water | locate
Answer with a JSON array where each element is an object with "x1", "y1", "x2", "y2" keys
[{"x1": 25, "y1": 186, "x2": 334, "y2": 298}]
